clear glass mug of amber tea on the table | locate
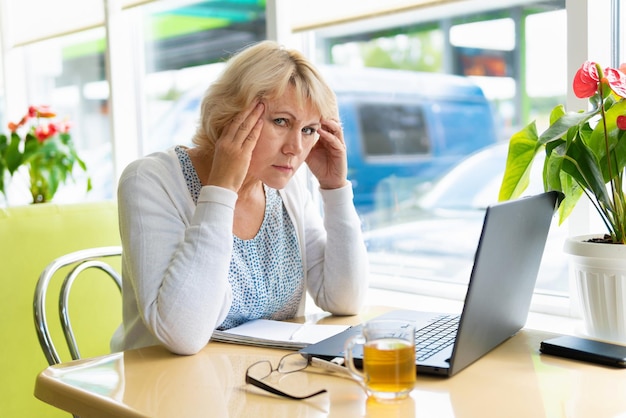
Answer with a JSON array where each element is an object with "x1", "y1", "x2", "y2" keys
[{"x1": 344, "y1": 320, "x2": 416, "y2": 400}]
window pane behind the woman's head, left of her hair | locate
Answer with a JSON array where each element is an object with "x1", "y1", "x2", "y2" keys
[{"x1": 139, "y1": 0, "x2": 265, "y2": 154}]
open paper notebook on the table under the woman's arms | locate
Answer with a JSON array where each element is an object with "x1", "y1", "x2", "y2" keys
[{"x1": 211, "y1": 319, "x2": 349, "y2": 350}]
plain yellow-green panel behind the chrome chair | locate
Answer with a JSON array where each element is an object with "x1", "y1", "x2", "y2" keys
[{"x1": 0, "y1": 202, "x2": 121, "y2": 418}]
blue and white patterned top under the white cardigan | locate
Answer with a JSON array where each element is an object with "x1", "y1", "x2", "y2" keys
[{"x1": 175, "y1": 147, "x2": 304, "y2": 329}]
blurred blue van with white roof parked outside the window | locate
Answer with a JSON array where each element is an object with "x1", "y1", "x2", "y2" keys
[{"x1": 144, "y1": 65, "x2": 496, "y2": 214}]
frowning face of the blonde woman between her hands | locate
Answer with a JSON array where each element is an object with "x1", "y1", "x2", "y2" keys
[{"x1": 248, "y1": 86, "x2": 321, "y2": 189}]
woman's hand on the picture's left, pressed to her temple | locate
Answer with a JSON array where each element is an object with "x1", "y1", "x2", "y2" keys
[{"x1": 207, "y1": 102, "x2": 265, "y2": 192}]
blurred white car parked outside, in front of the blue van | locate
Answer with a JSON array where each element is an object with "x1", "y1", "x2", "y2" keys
[{"x1": 365, "y1": 143, "x2": 568, "y2": 294}]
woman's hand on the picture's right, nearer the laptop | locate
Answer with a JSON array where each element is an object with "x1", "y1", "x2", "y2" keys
[{"x1": 306, "y1": 120, "x2": 348, "y2": 189}]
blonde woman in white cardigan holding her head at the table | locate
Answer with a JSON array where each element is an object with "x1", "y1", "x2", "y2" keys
[{"x1": 112, "y1": 41, "x2": 367, "y2": 354}]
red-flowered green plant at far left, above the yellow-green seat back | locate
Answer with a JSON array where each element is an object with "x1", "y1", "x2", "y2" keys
[{"x1": 0, "y1": 106, "x2": 91, "y2": 203}]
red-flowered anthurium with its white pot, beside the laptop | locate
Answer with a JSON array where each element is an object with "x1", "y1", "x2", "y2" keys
[{"x1": 499, "y1": 61, "x2": 626, "y2": 342}]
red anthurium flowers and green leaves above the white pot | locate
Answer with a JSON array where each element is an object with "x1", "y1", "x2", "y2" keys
[{"x1": 499, "y1": 61, "x2": 626, "y2": 244}]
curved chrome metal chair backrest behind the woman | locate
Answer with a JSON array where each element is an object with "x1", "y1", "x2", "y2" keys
[{"x1": 33, "y1": 246, "x2": 122, "y2": 365}]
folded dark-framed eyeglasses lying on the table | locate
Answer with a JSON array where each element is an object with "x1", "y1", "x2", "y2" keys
[{"x1": 246, "y1": 353, "x2": 326, "y2": 400}]
